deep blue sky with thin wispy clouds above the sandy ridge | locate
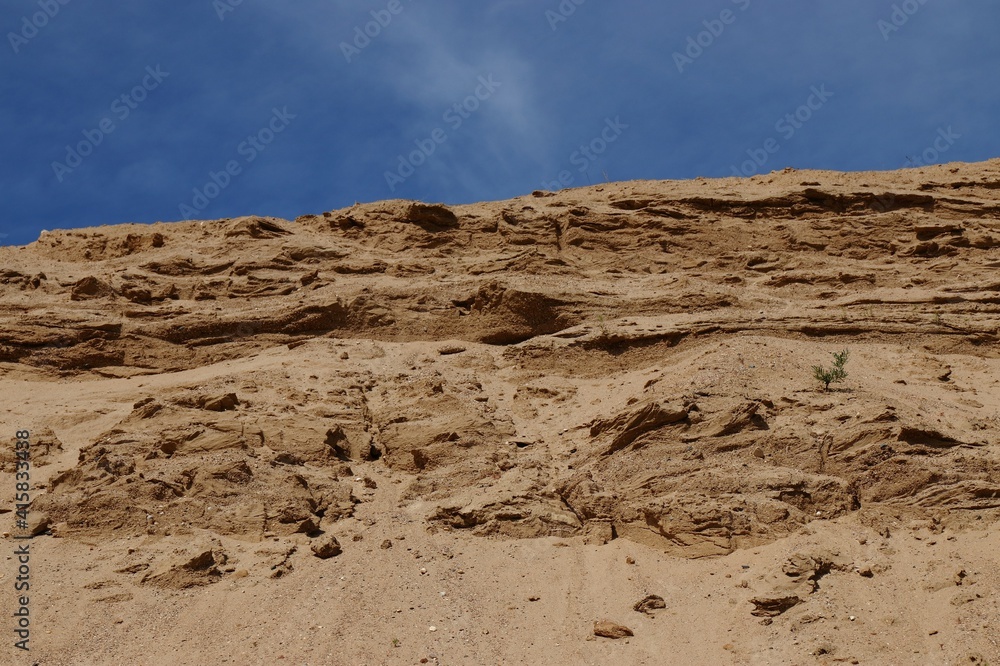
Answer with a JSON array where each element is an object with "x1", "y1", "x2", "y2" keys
[{"x1": 0, "y1": 0, "x2": 1000, "y2": 244}]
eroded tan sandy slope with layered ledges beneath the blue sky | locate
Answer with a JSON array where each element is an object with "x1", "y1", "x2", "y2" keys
[{"x1": 0, "y1": 160, "x2": 1000, "y2": 666}]
